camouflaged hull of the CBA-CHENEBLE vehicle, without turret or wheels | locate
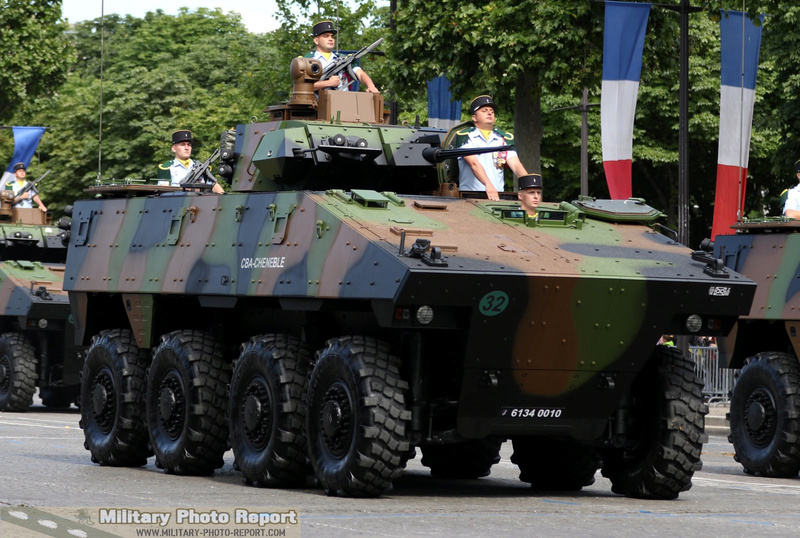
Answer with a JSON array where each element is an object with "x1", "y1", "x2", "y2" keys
[{"x1": 64, "y1": 181, "x2": 753, "y2": 439}]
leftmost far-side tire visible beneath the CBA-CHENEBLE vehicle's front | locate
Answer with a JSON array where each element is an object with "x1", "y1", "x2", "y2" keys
[{"x1": 420, "y1": 437, "x2": 503, "y2": 480}]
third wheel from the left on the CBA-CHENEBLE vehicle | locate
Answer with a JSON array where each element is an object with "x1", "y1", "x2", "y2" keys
[{"x1": 228, "y1": 334, "x2": 311, "y2": 486}]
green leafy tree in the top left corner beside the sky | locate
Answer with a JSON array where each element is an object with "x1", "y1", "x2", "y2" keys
[{"x1": 0, "y1": 0, "x2": 72, "y2": 122}]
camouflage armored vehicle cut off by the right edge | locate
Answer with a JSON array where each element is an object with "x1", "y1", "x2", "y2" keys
[{"x1": 707, "y1": 222, "x2": 800, "y2": 478}]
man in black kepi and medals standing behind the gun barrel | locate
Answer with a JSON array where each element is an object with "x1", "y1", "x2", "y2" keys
[{"x1": 456, "y1": 95, "x2": 528, "y2": 200}]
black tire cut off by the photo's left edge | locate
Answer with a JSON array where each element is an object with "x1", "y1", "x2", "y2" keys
[{"x1": 0, "y1": 333, "x2": 38, "y2": 411}]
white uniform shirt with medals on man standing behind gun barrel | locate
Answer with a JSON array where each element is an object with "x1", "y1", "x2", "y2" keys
[{"x1": 454, "y1": 126, "x2": 517, "y2": 192}]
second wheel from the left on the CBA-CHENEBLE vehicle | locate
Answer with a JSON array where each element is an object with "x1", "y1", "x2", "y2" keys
[{"x1": 145, "y1": 330, "x2": 231, "y2": 475}]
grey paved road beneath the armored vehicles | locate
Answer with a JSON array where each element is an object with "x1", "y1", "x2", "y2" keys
[{"x1": 0, "y1": 407, "x2": 800, "y2": 537}]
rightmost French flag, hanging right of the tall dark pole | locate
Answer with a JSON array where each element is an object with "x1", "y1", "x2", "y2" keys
[{"x1": 711, "y1": 11, "x2": 764, "y2": 237}]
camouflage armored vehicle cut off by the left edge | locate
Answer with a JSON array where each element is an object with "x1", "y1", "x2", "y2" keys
[{"x1": 0, "y1": 195, "x2": 83, "y2": 411}]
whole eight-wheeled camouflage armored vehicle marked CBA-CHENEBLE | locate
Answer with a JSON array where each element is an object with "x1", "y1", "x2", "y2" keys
[{"x1": 64, "y1": 59, "x2": 754, "y2": 499}]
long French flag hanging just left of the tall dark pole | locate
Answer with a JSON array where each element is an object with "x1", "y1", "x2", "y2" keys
[{"x1": 600, "y1": 1, "x2": 650, "y2": 200}]
